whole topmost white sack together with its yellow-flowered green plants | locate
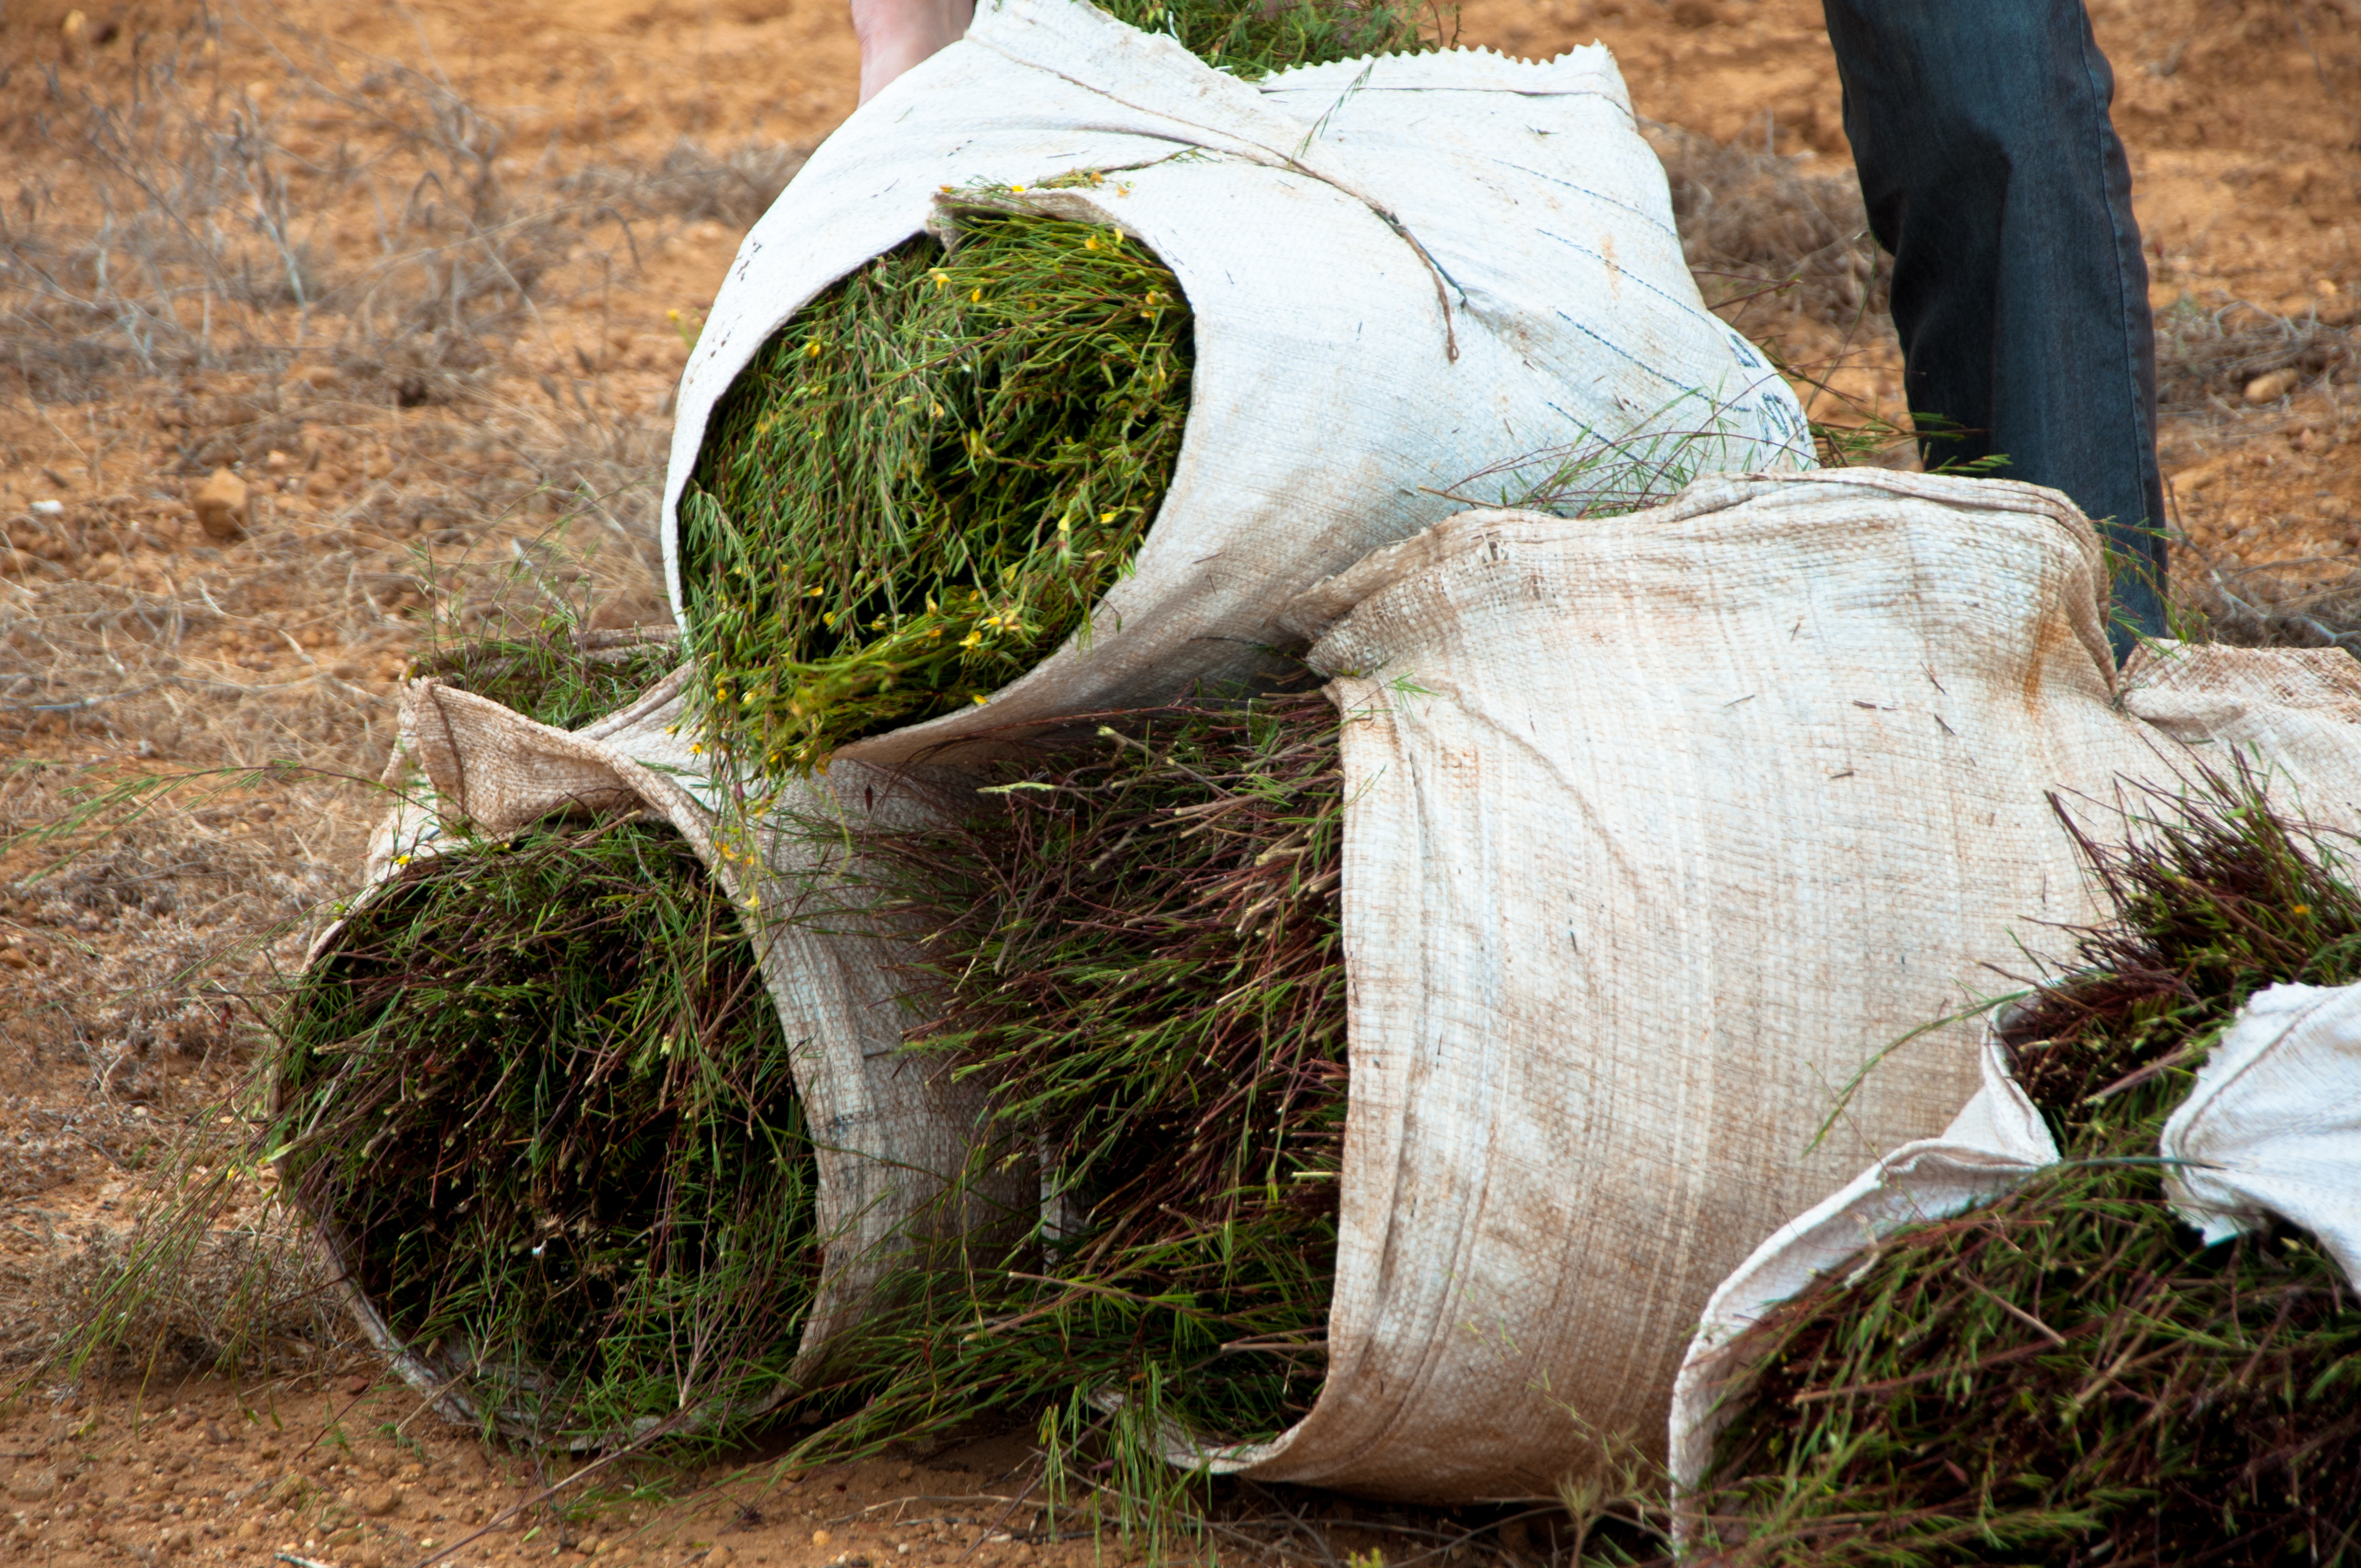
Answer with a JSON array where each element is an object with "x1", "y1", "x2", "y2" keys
[{"x1": 661, "y1": 0, "x2": 1809, "y2": 779}]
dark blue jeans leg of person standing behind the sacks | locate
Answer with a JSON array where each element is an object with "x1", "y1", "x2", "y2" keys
[{"x1": 1825, "y1": 0, "x2": 2165, "y2": 654}]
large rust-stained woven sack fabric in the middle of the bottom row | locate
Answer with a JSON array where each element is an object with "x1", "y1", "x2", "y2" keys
[{"x1": 1147, "y1": 470, "x2": 2342, "y2": 1500}]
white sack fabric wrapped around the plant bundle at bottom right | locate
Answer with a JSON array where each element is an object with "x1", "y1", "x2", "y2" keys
[{"x1": 1669, "y1": 982, "x2": 2361, "y2": 1540}]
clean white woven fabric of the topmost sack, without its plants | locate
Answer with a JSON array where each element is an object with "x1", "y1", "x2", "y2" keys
[{"x1": 663, "y1": 0, "x2": 1811, "y2": 763}]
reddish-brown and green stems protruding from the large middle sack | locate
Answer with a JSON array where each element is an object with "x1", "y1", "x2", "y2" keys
[{"x1": 805, "y1": 692, "x2": 1348, "y2": 1495}]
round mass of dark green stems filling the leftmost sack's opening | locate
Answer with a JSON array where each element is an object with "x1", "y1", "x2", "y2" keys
[{"x1": 267, "y1": 819, "x2": 822, "y2": 1445}]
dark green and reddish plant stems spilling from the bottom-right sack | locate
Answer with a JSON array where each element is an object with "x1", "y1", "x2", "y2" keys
[{"x1": 1700, "y1": 775, "x2": 2361, "y2": 1568}]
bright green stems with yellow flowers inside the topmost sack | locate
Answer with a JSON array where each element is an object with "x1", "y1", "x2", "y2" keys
[{"x1": 680, "y1": 208, "x2": 1192, "y2": 772}]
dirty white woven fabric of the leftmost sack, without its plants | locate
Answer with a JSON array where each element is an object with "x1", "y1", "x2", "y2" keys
[{"x1": 312, "y1": 666, "x2": 1015, "y2": 1438}]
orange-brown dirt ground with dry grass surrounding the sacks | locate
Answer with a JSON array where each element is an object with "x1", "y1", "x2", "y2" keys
[{"x1": 0, "y1": 0, "x2": 2361, "y2": 1568}]
